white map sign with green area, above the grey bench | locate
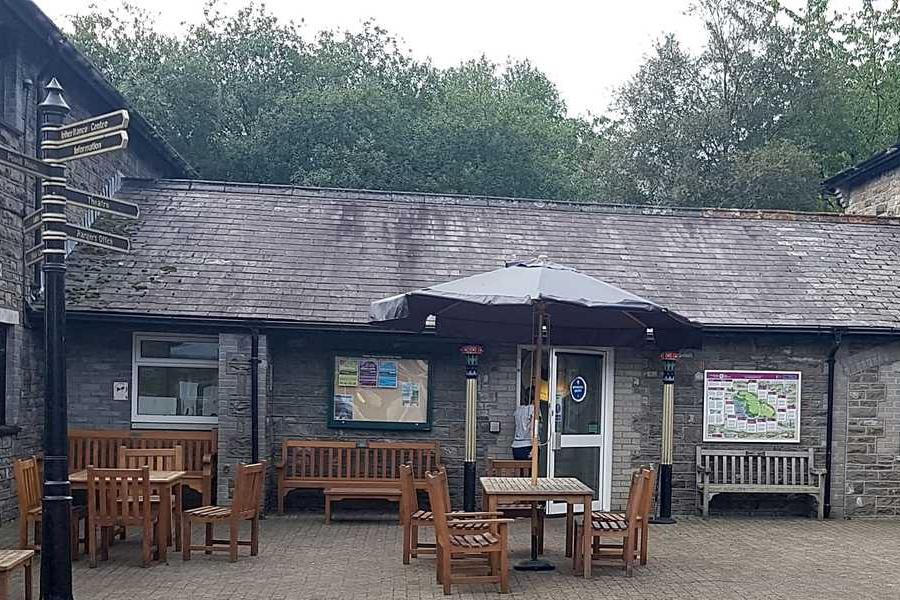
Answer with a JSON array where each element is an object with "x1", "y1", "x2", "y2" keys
[{"x1": 703, "y1": 371, "x2": 800, "y2": 442}]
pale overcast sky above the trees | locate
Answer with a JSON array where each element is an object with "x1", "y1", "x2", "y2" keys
[{"x1": 36, "y1": 0, "x2": 860, "y2": 114}]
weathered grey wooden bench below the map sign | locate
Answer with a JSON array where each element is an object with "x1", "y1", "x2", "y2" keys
[{"x1": 697, "y1": 446, "x2": 825, "y2": 520}]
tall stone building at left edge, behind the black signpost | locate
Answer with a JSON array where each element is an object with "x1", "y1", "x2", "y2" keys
[{"x1": 0, "y1": 0, "x2": 193, "y2": 519}]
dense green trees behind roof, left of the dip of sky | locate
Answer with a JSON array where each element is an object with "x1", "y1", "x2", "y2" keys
[{"x1": 73, "y1": 4, "x2": 593, "y2": 199}]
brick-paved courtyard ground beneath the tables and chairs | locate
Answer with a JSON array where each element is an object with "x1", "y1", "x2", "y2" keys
[{"x1": 0, "y1": 512, "x2": 900, "y2": 600}]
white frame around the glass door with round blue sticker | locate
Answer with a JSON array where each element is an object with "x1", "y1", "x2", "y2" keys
[{"x1": 515, "y1": 344, "x2": 616, "y2": 514}]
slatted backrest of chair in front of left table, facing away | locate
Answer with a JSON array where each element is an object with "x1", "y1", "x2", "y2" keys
[{"x1": 87, "y1": 467, "x2": 153, "y2": 527}]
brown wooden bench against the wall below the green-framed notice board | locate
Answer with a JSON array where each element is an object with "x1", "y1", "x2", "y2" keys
[{"x1": 276, "y1": 440, "x2": 441, "y2": 513}]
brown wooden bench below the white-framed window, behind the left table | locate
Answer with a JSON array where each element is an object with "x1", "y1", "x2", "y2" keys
[{"x1": 69, "y1": 429, "x2": 218, "y2": 506}]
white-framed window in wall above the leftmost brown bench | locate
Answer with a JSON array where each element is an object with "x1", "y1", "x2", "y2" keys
[{"x1": 131, "y1": 333, "x2": 219, "y2": 427}]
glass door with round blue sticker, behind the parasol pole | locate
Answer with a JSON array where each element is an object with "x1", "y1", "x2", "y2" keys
[{"x1": 548, "y1": 349, "x2": 612, "y2": 514}]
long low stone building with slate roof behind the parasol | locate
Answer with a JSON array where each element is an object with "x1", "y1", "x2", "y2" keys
[{"x1": 59, "y1": 179, "x2": 900, "y2": 515}]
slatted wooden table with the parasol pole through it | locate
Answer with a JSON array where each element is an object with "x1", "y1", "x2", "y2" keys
[{"x1": 481, "y1": 477, "x2": 594, "y2": 577}]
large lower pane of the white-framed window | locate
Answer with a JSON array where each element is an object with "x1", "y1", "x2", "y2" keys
[{"x1": 138, "y1": 367, "x2": 219, "y2": 417}]
